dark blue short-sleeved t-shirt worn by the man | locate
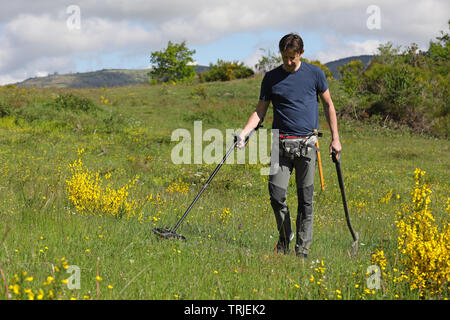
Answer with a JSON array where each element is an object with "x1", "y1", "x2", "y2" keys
[{"x1": 259, "y1": 62, "x2": 328, "y2": 136}]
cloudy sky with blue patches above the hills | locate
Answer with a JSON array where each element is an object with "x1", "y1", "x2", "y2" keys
[{"x1": 0, "y1": 0, "x2": 450, "y2": 85}]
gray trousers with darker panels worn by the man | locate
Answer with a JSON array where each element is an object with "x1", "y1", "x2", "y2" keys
[{"x1": 269, "y1": 142, "x2": 316, "y2": 254}]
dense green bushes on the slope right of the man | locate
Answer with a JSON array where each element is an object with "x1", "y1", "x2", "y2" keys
[{"x1": 338, "y1": 24, "x2": 450, "y2": 137}]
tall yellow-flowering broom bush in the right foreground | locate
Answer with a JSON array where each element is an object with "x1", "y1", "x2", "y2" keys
[{"x1": 396, "y1": 169, "x2": 450, "y2": 297}]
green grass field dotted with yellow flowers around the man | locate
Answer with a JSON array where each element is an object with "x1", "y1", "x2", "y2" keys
[{"x1": 0, "y1": 77, "x2": 450, "y2": 299}]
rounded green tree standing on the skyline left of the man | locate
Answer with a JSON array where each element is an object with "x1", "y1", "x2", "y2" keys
[{"x1": 149, "y1": 41, "x2": 195, "y2": 82}]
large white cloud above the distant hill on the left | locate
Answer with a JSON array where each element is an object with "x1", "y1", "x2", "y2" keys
[{"x1": 0, "y1": 14, "x2": 161, "y2": 84}]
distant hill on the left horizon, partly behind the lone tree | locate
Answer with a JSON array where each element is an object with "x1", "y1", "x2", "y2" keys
[{"x1": 15, "y1": 66, "x2": 209, "y2": 88}]
